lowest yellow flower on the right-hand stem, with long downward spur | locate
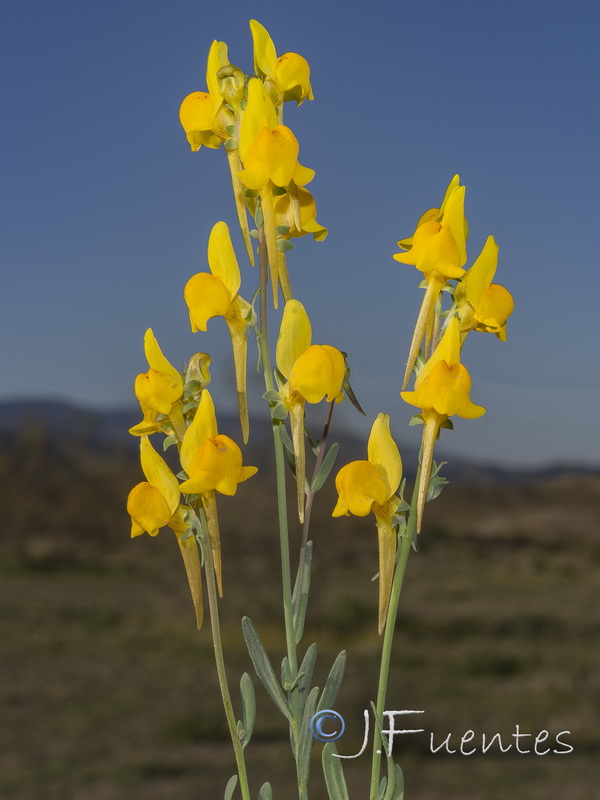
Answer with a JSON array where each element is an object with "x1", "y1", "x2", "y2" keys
[{"x1": 332, "y1": 414, "x2": 402, "y2": 634}]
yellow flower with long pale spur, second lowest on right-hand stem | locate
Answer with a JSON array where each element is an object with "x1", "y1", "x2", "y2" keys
[{"x1": 400, "y1": 317, "x2": 485, "y2": 533}]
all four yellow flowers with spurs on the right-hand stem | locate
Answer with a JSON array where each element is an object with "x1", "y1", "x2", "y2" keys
[{"x1": 333, "y1": 175, "x2": 513, "y2": 633}]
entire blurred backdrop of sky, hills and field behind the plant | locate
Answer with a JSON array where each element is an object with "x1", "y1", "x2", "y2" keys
[{"x1": 0, "y1": 0, "x2": 600, "y2": 800}]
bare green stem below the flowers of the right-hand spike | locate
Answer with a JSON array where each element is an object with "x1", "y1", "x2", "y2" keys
[{"x1": 369, "y1": 465, "x2": 421, "y2": 800}]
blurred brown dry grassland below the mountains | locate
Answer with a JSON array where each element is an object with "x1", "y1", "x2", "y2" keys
[{"x1": 0, "y1": 434, "x2": 600, "y2": 800}]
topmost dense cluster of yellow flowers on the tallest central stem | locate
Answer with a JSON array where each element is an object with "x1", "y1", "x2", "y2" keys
[{"x1": 180, "y1": 20, "x2": 327, "y2": 307}]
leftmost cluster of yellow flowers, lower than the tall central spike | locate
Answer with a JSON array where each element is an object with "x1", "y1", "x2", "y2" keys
[{"x1": 127, "y1": 322, "x2": 257, "y2": 628}]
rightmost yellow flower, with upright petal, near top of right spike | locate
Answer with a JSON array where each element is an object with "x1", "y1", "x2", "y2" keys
[{"x1": 456, "y1": 236, "x2": 515, "y2": 342}]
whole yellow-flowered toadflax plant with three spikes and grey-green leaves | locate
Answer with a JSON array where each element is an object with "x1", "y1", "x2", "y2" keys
[{"x1": 127, "y1": 20, "x2": 513, "y2": 800}]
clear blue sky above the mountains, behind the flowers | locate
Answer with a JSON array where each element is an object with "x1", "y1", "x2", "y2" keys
[{"x1": 0, "y1": 0, "x2": 600, "y2": 465}]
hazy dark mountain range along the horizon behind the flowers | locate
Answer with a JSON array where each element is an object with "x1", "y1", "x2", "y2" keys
[{"x1": 0, "y1": 399, "x2": 600, "y2": 483}]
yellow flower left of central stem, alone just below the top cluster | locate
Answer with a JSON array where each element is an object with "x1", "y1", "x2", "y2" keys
[{"x1": 184, "y1": 222, "x2": 252, "y2": 442}]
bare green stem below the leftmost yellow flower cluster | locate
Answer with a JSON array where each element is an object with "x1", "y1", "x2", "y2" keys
[{"x1": 198, "y1": 504, "x2": 251, "y2": 800}]
